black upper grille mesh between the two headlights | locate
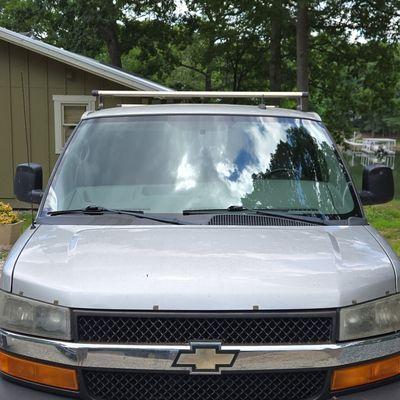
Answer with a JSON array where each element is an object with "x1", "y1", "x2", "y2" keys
[{"x1": 77, "y1": 313, "x2": 333, "y2": 344}]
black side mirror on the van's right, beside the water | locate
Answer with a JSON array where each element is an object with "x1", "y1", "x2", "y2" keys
[{"x1": 360, "y1": 164, "x2": 394, "y2": 206}]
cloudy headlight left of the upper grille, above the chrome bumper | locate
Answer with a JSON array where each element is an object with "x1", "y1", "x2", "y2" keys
[{"x1": 0, "y1": 291, "x2": 71, "y2": 340}]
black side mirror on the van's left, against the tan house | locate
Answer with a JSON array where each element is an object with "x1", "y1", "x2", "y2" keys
[{"x1": 14, "y1": 163, "x2": 43, "y2": 204}]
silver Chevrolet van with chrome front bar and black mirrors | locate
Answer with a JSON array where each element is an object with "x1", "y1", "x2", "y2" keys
[{"x1": 0, "y1": 92, "x2": 400, "y2": 400}]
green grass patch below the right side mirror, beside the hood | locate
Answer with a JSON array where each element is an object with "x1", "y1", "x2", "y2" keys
[{"x1": 365, "y1": 200, "x2": 400, "y2": 256}]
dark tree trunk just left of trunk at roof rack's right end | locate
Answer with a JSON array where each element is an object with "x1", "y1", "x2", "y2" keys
[{"x1": 269, "y1": 0, "x2": 282, "y2": 92}]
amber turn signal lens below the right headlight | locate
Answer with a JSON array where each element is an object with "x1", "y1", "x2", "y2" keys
[{"x1": 331, "y1": 356, "x2": 400, "y2": 390}]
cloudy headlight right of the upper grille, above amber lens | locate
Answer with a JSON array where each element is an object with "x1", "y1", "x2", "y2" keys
[{"x1": 339, "y1": 295, "x2": 400, "y2": 340}]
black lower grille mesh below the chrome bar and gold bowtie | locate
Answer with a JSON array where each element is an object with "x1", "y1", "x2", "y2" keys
[{"x1": 84, "y1": 370, "x2": 327, "y2": 400}]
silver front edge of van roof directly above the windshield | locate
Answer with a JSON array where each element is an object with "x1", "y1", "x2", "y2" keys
[{"x1": 82, "y1": 103, "x2": 321, "y2": 121}]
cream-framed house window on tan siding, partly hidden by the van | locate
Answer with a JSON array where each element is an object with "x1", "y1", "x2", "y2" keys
[{"x1": 53, "y1": 95, "x2": 96, "y2": 154}]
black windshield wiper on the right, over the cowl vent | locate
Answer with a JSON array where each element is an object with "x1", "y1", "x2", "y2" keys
[{"x1": 182, "y1": 206, "x2": 326, "y2": 225}]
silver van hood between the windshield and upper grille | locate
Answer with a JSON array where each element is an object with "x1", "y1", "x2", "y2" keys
[{"x1": 8, "y1": 225, "x2": 396, "y2": 310}]
